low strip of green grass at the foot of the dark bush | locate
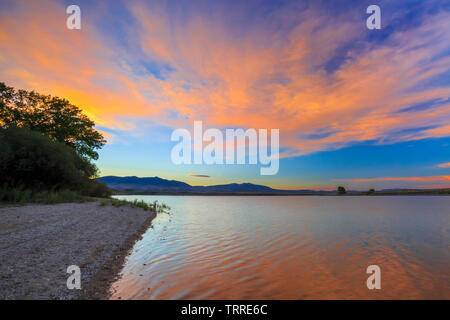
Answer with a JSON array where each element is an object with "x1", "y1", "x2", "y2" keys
[{"x1": 0, "y1": 187, "x2": 91, "y2": 205}]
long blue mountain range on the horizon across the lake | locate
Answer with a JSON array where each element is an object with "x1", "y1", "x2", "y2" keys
[{"x1": 97, "y1": 176, "x2": 334, "y2": 194}]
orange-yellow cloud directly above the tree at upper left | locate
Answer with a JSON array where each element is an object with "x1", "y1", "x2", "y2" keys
[{"x1": 0, "y1": 0, "x2": 160, "y2": 129}]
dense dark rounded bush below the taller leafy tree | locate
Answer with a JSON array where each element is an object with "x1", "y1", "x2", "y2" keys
[{"x1": 0, "y1": 127, "x2": 111, "y2": 198}]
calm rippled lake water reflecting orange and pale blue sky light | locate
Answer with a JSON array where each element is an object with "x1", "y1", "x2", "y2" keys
[{"x1": 112, "y1": 196, "x2": 450, "y2": 299}]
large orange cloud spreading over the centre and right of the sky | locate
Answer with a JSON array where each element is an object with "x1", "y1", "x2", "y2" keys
[{"x1": 115, "y1": 5, "x2": 450, "y2": 156}]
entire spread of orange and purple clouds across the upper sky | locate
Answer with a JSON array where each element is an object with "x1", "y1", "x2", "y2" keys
[{"x1": 0, "y1": 0, "x2": 450, "y2": 157}]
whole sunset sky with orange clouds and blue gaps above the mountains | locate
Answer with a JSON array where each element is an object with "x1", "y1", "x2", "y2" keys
[{"x1": 0, "y1": 0, "x2": 450, "y2": 190}]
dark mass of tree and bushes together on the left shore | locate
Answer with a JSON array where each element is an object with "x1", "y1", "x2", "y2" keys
[{"x1": 0, "y1": 82, "x2": 110, "y2": 196}]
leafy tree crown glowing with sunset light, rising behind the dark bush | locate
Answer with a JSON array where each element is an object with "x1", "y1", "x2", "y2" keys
[{"x1": 0, "y1": 82, "x2": 106, "y2": 160}]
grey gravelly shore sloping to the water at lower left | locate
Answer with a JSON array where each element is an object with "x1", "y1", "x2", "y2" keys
[{"x1": 0, "y1": 202, "x2": 155, "y2": 299}]
